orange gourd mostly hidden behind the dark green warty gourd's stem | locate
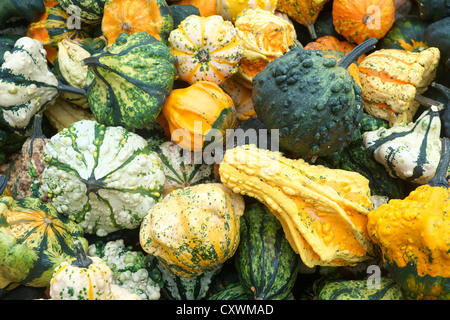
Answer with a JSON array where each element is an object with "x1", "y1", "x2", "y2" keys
[{"x1": 304, "y1": 36, "x2": 366, "y2": 86}]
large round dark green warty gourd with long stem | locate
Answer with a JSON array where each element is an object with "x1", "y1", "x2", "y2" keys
[{"x1": 252, "y1": 38, "x2": 377, "y2": 156}]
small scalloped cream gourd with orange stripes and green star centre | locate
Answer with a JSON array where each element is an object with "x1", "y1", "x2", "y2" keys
[{"x1": 169, "y1": 15, "x2": 243, "y2": 84}]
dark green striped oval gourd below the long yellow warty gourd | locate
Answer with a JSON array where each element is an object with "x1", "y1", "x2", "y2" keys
[{"x1": 235, "y1": 202, "x2": 300, "y2": 300}]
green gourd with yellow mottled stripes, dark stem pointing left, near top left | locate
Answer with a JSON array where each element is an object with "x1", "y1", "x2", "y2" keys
[{"x1": 83, "y1": 32, "x2": 176, "y2": 131}]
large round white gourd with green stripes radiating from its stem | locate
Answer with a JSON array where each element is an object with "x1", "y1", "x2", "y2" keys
[{"x1": 41, "y1": 120, "x2": 165, "y2": 236}]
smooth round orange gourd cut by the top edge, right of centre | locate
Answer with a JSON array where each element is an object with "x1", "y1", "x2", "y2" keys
[{"x1": 332, "y1": 0, "x2": 395, "y2": 44}]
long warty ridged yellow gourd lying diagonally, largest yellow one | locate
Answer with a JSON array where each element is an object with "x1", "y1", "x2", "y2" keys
[{"x1": 219, "y1": 145, "x2": 373, "y2": 267}]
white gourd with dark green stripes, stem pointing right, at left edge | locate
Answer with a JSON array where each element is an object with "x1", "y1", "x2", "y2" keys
[{"x1": 0, "y1": 37, "x2": 84, "y2": 135}]
